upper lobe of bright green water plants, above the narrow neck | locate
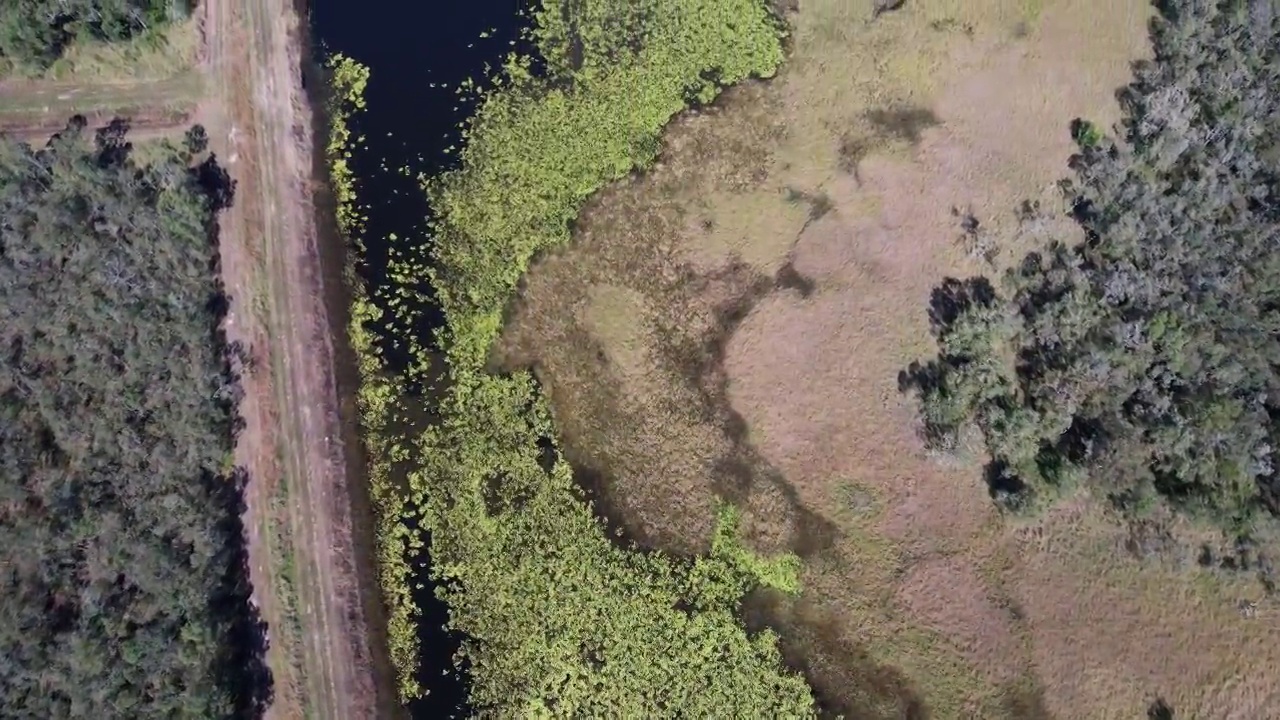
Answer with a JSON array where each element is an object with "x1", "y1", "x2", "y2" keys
[{"x1": 428, "y1": 0, "x2": 782, "y2": 374}]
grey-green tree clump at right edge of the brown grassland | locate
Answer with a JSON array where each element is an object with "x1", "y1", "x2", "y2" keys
[{"x1": 902, "y1": 0, "x2": 1280, "y2": 536}]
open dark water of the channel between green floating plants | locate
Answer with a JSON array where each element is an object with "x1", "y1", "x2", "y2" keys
[{"x1": 311, "y1": 0, "x2": 527, "y2": 720}]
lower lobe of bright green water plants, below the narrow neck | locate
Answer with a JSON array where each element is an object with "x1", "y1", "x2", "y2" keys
[{"x1": 413, "y1": 374, "x2": 810, "y2": 716}]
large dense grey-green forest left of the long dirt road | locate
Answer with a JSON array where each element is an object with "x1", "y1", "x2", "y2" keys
[{"x1": 0, "y1": 118, "x2": 269, "y2": 717}]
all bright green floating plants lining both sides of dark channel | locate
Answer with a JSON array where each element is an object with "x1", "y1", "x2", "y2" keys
[{"x1": 330, "y1": 0, "x2": 812, "y2": 716}]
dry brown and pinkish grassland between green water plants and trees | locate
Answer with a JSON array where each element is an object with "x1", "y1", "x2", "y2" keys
[{"x1": 494, "y1": 0, "x2": 1280, "y2": 720}]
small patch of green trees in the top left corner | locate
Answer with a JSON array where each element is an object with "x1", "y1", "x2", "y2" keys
[{"x1": 0, "y1": 0, "x2": 189, "y2": 67}]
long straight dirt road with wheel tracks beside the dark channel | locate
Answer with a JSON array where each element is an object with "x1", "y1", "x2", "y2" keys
[{"x1": 198, "y1": 0, "x2": 378, "y2": 720}]
